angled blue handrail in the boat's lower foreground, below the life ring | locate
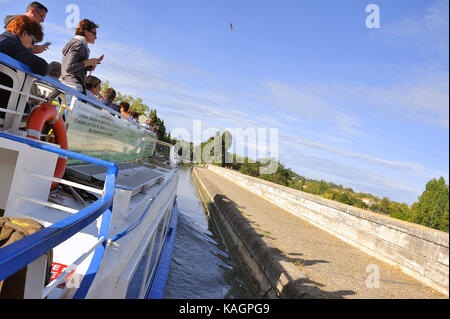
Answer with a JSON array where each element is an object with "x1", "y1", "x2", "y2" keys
[{"x1": 0, "y1": 132, "x2": 118, "y2": 298}]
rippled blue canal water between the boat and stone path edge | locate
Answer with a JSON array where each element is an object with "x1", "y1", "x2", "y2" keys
[{"x1": 163, "y1": 167, "x2": 251, "y2": 299}]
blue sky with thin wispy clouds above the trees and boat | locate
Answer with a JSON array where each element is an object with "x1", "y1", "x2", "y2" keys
[{"x1": 0, "y1": 0, "x2": 449, "y2": 204}]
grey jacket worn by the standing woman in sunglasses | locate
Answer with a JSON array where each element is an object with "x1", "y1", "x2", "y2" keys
[{"x1": 60, "y1": 37, "x2": 91, "y2": 89}]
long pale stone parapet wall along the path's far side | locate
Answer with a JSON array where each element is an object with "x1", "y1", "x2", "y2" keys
[{"x1": 207, "y1": 165, "x2": 449, "y2": 295}]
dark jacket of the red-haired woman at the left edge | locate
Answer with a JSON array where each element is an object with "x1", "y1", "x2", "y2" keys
[{"x1": 0, "y1": 31, "x2": 49, "y2": 75}]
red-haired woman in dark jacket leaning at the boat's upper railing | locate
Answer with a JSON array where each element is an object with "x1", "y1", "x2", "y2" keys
[{"x1": 0, "y1": 15, "x2": 49, "y2": 75}]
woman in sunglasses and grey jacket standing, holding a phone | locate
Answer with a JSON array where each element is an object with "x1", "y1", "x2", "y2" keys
[{"x1": 60, "y1": 19, "x2": 100, "y2": 94}]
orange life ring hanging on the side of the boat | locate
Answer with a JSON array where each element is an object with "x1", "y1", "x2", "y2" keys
[{"x1": 26, "y1": 103, "x2": 69, "y2": 190}]
